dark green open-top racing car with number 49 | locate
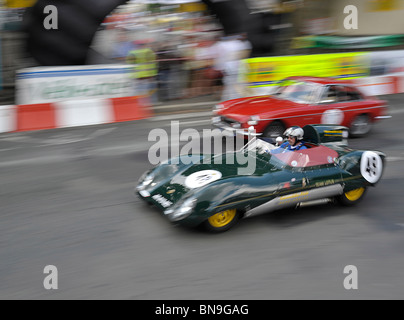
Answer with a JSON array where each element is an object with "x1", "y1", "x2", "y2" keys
[{"x1": 135, "y1": 125, "x2": 386, "y2": 232}]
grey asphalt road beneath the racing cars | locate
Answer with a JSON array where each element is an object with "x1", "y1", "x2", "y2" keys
[{"x1": 0, "y1": 95, "x2": 404, "y2": 300}]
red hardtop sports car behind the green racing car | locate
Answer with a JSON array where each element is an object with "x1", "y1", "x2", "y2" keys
[{"x1": 212, "y1": 77, "x2": 390, "y2": 138}]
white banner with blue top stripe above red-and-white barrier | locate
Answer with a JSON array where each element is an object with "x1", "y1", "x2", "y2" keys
[{"x1": 16, "y1": 65, "x2": 133, "y2": 104}]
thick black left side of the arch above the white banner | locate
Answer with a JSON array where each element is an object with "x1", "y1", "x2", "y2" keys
[{"x1": 23, "y1": 0, "x2": 127, "y2": 66}]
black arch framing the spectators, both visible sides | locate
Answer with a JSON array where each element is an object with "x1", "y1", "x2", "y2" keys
[{"x1": 23, "y1": 0, "x2": 281, "y2": 66}]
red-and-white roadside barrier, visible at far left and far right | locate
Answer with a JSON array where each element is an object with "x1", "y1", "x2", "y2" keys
[{"x1": 0, "y1": 73, "x2": 404, "y2": 133}]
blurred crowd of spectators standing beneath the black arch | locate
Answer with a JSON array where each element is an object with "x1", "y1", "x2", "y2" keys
[{"x1": 102, "y1": 10, "x2": 251, "y2": 103}]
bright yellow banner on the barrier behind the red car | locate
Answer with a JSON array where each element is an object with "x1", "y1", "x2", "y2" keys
[{"x1": 246, "y1": 52, "x2": 370, "y2": 87}]
